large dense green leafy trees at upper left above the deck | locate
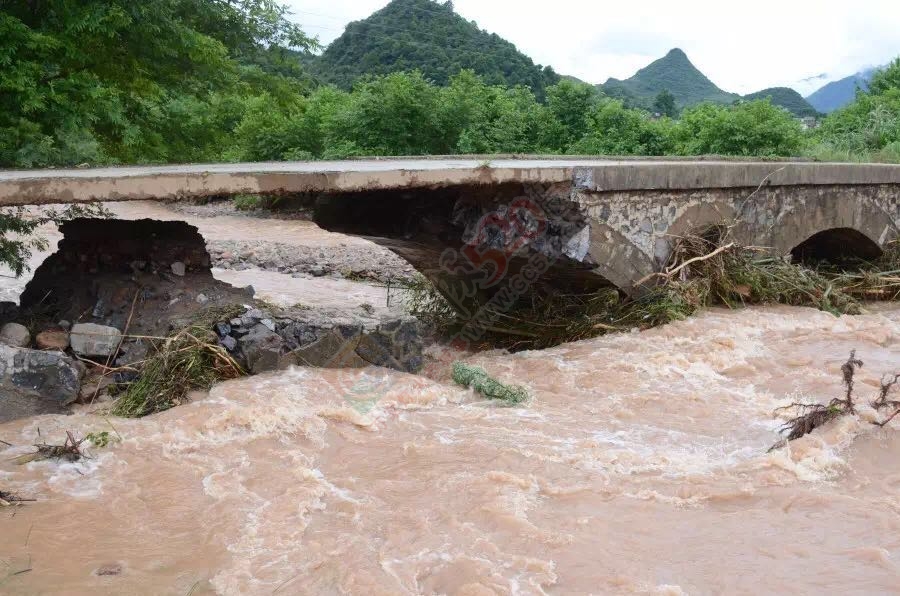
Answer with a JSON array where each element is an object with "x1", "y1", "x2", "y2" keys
[{"x1": 0, "y1": 0, "x2": 314, "y2": 167}]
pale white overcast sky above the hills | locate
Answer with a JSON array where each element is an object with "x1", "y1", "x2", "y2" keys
[{"x1": 282, "y1": 0, "x2": 900, "y2": 95}]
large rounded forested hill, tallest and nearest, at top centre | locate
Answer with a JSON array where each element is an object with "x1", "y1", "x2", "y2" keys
[{"x1": 310, "y1": 0, "x2": 559, "y2": 97}]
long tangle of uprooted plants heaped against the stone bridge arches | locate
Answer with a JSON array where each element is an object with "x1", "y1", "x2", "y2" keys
[{"x1": 404, "y1": 225, "x2": 900, "y2": 350}]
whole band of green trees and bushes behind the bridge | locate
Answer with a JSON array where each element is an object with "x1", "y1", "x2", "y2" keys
[{"x1": 0, "y1": 0, "x2": 900, "y2": 167}]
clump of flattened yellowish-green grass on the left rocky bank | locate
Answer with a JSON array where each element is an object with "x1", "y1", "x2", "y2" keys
[{"x1": 112, "y1": 307, "x2": 247, "y2": 418}]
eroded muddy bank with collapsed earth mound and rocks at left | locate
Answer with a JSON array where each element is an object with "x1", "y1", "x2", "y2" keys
[{"x1": 0, "y1": 219, "x2": 423, "y2": 421}]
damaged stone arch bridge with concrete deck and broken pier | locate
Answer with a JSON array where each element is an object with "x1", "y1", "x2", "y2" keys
[{"x1": 0, "y1": 158, "x2": 900, "y2": 298}]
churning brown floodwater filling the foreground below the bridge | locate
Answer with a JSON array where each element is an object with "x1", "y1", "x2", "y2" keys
[{"x1": 0, "y1": 204, "x2": 900, "y2": 596}]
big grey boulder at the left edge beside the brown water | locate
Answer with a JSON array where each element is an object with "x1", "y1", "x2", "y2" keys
[{"x1": 0, "y1": 344, "x2": 81, "y2": 423}]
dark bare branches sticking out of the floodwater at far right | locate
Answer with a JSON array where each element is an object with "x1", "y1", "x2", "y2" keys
[{"x1": 769, "y1": 350, "x2": 900, "y2": 451}]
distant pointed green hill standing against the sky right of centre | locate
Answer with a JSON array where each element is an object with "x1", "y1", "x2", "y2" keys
[{"x1": 600, "y1": 48, "x2": 739, "y2": 107}]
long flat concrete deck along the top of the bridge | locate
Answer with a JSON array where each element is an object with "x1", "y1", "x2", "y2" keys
[{"x1": 0, "y1": 158, "x2": 900, "y2": 206}]
